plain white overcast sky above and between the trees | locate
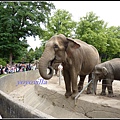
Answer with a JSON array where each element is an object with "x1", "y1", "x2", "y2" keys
[{"x1": 28, "y1": 1, "x2": 120, "y2": 49}]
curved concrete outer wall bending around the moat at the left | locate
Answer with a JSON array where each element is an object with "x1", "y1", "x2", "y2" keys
[{"x1": 0, "y1": 70, "x2": 51, "y2": 118}]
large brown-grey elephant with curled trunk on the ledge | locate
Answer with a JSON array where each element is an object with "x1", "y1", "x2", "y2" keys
[{"x1": 39, "y1": 34, "x2": 100, "y2": 99}]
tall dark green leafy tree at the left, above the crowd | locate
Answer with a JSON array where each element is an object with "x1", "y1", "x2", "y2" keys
[{"x1": 0, "y1": 1, "x2": 54, "y2": 64}]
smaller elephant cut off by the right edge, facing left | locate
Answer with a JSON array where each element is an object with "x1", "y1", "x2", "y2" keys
[{"x1": 93, "y1": 58, "x2": 120, "y2": 97}]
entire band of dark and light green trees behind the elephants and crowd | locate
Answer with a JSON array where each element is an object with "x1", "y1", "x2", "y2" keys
[{"x1": 0, "y1": 1, "x2": 120, "y2": 64}]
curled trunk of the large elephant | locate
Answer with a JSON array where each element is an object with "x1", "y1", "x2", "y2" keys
[{"x1": 38, "y1": 49, "x2": 54, "y2": 80}]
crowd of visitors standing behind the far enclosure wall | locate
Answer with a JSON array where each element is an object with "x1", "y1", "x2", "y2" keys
[{"x1": 0, "y1": 63, "x2": 37, "y2": 75}]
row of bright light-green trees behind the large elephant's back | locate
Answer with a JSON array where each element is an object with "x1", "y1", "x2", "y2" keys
[{"x1": 39, "y1": 10, "x2": 120, "y2": 61}]
